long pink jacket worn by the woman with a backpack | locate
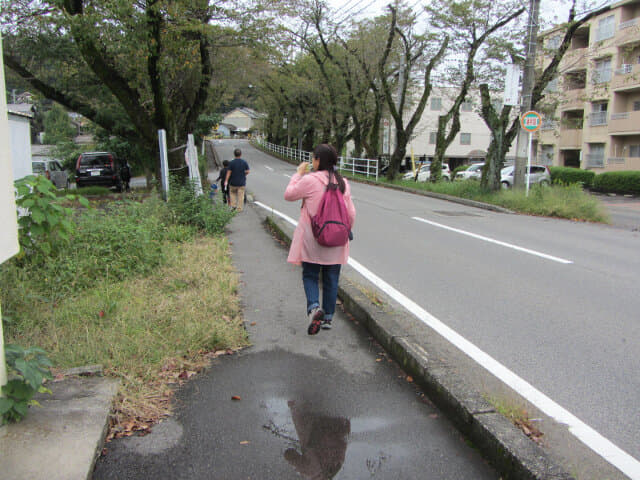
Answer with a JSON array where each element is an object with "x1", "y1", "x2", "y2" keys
[{"x1": 284, "y1": 170, "x2": 356, "y2": 265}]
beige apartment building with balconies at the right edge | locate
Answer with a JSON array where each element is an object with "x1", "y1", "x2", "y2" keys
[{"x1": 535, "y1": 0, "x2": 640, "y2": 173}]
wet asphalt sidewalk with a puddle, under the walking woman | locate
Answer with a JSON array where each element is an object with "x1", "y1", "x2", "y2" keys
[{"x1": 94, "y1": 206, "x2": 500, "y2": 480}]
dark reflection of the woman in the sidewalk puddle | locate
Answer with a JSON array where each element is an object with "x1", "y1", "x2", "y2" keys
[{"x1": 284, "y1": 400, "x2": 351, "y2": 480}]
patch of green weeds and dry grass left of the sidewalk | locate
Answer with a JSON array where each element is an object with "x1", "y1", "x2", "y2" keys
[{"x1": 0, "y1": 191, "x2": 247, "y2": 432}]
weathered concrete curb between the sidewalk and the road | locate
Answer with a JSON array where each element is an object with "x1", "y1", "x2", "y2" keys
[{"x1": 258, "y1": 208, "x2": 573, "y2": 480}]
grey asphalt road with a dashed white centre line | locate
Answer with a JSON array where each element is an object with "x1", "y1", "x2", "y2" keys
[{"x1": 211, "y1": 141, "x2": 640, "y2": 476}]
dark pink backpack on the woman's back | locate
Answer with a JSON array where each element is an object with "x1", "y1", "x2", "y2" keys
[{"x1": 311, "y1": 172, "x2": 352, "y2": 247}]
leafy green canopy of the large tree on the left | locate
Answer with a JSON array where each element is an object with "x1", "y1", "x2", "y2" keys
[{"x1": 2, "y1": 0, "x2": 288, "y2": 175}]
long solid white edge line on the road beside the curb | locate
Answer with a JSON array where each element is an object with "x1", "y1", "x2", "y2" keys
[{"x1": 255, "y1": 202, "x2": 640, "y2": 480}]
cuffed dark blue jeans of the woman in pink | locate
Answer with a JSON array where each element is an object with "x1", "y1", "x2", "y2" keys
[{"x1": 302, "y1": 262, "x2": 342, "y2": 320}]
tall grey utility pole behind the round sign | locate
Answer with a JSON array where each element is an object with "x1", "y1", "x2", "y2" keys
[{"x1": 513, "y1": 0, "x2": 540, "y2": 188}]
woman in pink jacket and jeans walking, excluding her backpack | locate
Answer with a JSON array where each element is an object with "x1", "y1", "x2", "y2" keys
[{"x1": 284, "y1": 143, "x2": 356, "y2": 335}]
